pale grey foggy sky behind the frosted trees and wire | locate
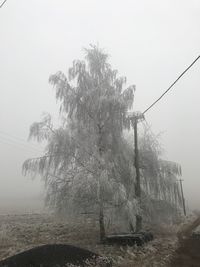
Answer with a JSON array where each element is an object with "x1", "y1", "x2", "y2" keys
[{"x1": 0, "y1": 0, "x2": 200, "y2": 214}]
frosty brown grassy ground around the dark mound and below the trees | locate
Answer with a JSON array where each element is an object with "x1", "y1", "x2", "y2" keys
[{"x1": 0, "y1": 214, "x2": 177, "y2": 267}]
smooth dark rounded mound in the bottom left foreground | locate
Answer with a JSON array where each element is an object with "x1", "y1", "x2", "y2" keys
[{"x1": 0, "y1": 244, "x2": 112, "y2": 267}]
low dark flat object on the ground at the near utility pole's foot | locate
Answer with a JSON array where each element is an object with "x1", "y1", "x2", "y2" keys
[{"x1": 104, "y1": 232, "x2": 153, "y2": 246}]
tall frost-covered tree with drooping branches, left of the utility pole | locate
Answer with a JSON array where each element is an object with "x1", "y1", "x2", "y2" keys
[{"x1": 23, "y1": 46, "x2": 135, "y2": 240}]
